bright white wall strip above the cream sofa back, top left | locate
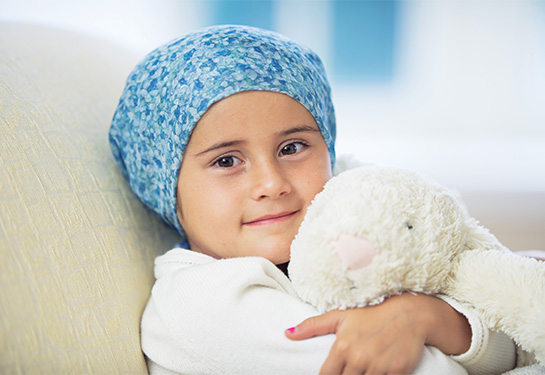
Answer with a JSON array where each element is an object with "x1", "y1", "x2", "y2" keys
[{"x1": 0, "y1": 0, "x2": 204, "y2": 53}]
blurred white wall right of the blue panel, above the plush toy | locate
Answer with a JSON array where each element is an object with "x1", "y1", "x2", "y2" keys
[{"x1": 337, "y1": 0, "x2": 545, "y2": 192}]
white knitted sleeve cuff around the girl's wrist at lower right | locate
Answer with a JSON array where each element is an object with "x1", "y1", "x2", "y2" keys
[{"x1": 438, "y1": 295, "x2": 517, "y2": 375}]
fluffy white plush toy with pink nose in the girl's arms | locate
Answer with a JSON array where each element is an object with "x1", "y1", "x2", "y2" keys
[{"x1": 288, "y1": 166, "x2": 545, "y2": 368}]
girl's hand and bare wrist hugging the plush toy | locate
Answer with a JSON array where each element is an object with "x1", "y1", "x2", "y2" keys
[{"x1": 286, "y1": 293, "x2": 471, "y2": 374}]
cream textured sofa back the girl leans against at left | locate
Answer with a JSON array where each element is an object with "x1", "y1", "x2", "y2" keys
[{"x1": 0, "y1": 23, "x2": 178, "y2": 374}]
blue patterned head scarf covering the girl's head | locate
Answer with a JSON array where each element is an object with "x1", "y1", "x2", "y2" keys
[{"x1": 110, "y1": 26, "x2": 336, "y2": 237}]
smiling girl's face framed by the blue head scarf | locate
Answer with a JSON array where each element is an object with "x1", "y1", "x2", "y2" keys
[{"x1": 177, "y1": 91, "x2": 331, "y2": 264}]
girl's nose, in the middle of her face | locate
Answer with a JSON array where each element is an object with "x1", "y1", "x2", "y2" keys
[{"x1": 250, "y1": 161, "x2": 292, "y2": 200}]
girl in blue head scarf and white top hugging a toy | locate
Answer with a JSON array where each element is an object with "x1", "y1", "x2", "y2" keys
[{"x1": 110, "y1": 26, "x2": 515, "y2": 374}]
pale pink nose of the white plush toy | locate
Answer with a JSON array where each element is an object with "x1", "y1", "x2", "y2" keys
[{"x1": 331, "y1": 234, "x2": 380, "y2": 270}]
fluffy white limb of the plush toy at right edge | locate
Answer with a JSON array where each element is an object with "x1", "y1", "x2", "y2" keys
[{"x1": 445, "y1": 250, "x2": 545, "y2": 364}]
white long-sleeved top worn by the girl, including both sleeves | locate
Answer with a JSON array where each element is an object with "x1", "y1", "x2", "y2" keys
[{"x1": 141, "y1": 248, "x2": 515, "y2": 375}]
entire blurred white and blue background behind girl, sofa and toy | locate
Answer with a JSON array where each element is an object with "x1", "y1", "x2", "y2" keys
[{"x1": 0, "y1": 0, "x2": 545, "y2": 250}]
